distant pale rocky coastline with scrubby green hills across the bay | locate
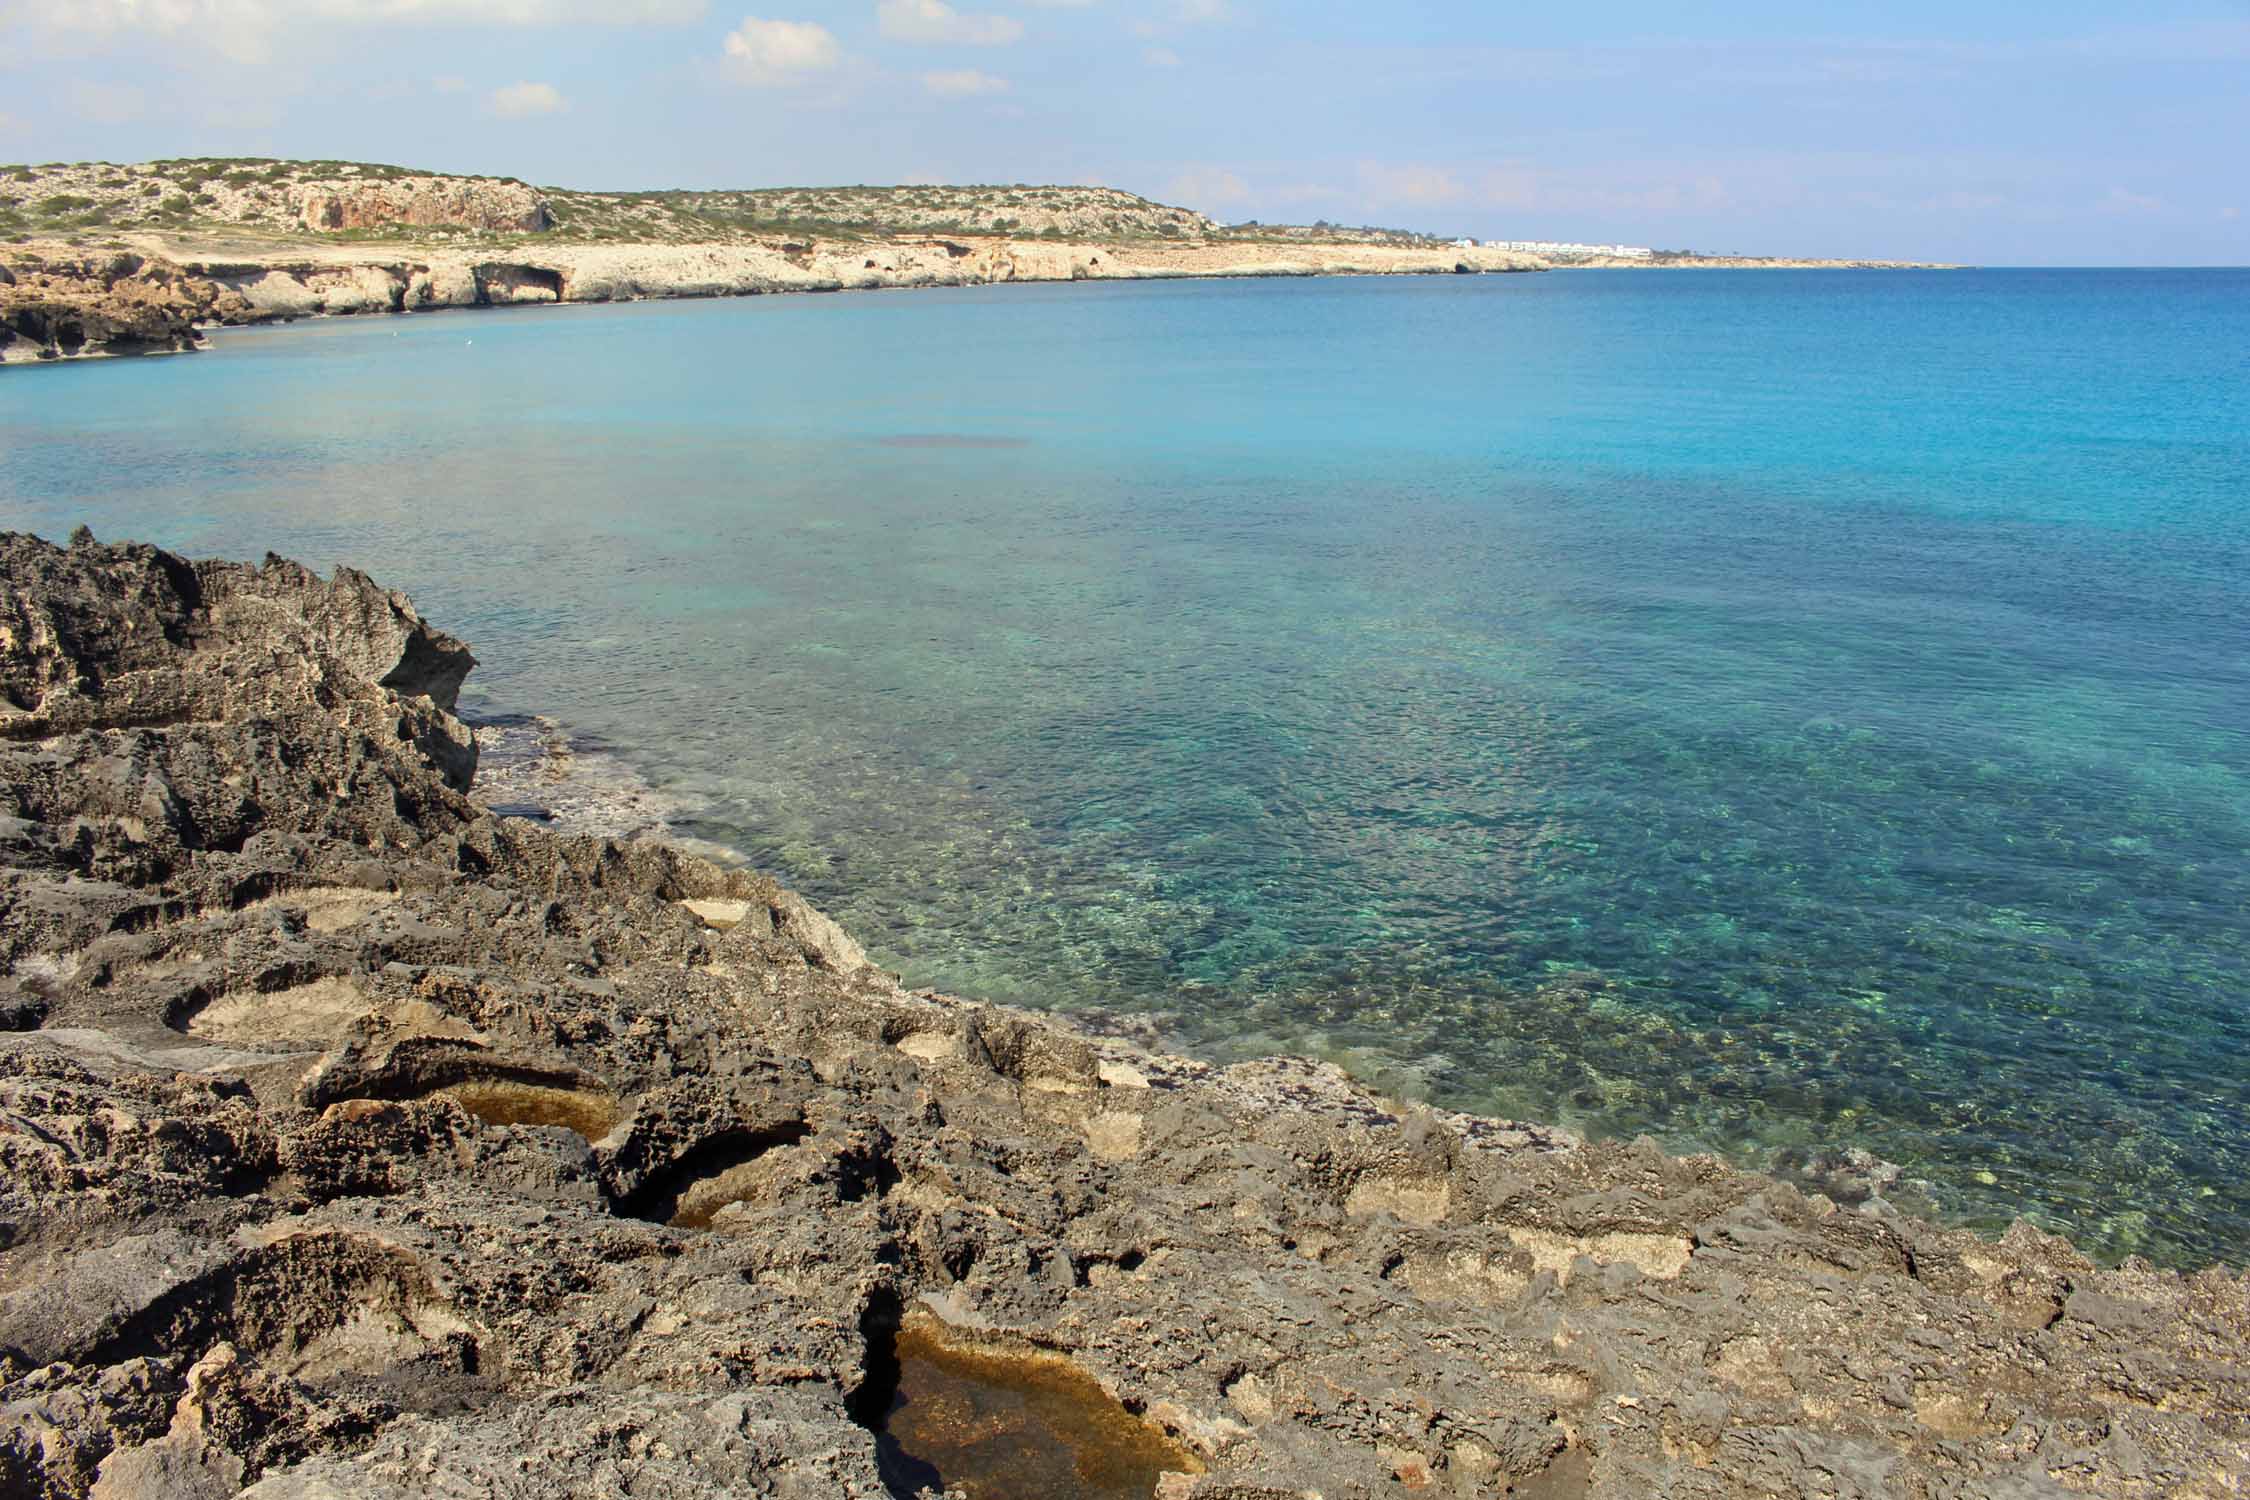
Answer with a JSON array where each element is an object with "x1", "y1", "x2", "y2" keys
[{"x1": 0, "y1": 160, "x2": 1926, "y2": 364}]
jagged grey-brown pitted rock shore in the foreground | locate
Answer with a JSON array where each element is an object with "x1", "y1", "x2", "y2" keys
[{"x1": 0, "y1": 533, "x2": 2250, "y2": 1500}]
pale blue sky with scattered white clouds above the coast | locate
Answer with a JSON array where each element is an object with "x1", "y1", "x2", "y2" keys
[{"x1": 0, "y1": 0, "x2": 2250, "y2": 265}]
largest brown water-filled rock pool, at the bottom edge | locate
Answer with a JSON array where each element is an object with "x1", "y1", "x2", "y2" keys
[{"x1": 875, "y1": 1318, "x2": 1202, "y2": 1500}]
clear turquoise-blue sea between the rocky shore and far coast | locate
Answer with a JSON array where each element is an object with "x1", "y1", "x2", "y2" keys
[{"x1": 0, "y1": 272, "x2": 2250, "y2": 1262}]
